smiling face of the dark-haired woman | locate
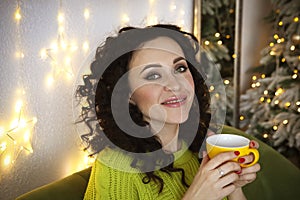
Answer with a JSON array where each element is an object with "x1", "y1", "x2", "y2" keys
[{"x1": 128, "y1": 37, "x2": 194, "y2": 124}]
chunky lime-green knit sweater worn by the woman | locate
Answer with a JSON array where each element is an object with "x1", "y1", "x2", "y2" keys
[{"x1": 84, "y1": 141, "x2": 226, "y2": 200}]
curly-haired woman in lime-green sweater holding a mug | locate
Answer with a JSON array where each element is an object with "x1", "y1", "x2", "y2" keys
[{"x1": 77, "y1": 25, "x2": 260, "y2": 200}]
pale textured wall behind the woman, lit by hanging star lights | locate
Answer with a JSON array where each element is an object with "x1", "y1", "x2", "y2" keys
[{"x1": 0, "y1": 0, "x2": 192, "y2": 199}]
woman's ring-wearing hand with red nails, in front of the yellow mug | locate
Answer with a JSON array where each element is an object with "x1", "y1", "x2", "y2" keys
[{"x1": 183, "y1": 152, "x2": 241, "y2": 200}]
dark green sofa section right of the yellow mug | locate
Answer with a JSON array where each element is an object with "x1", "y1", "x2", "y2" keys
[{"x1": 222, "y1": 126, "x2": 300, "y2": 200}]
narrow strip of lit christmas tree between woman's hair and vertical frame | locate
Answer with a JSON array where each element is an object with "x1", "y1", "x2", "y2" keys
[{"x1": 201, "y1": 0, "x2": 235, "y2": 125}]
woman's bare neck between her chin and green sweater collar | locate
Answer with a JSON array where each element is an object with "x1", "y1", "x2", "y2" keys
[{"x1": 151, "y1": 123, "x2": 181, "y2": 153}]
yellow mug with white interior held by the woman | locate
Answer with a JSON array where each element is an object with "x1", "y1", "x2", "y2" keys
[{"x1": 206, "y1": 134, "x2": 259, "y2": 167}]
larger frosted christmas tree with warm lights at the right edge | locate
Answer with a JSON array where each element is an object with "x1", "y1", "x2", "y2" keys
[{"x1": 240, "y1": 0, "x2": 300, "y2": 159}]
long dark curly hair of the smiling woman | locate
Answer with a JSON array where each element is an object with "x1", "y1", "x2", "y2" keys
[{"x1": 76, "y1": 24, "x2": 211, "y2": 192}]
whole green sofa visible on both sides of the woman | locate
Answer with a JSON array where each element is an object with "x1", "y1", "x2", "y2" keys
[{"x1": 17, "y1": 126, "x2": 300, "y2": 200}]
